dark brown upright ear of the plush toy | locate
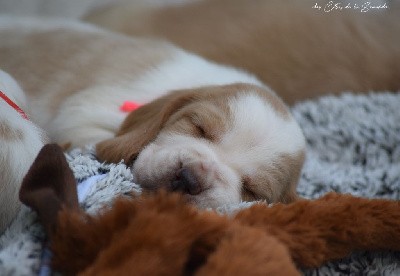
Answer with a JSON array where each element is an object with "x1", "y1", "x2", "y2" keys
[{"x1": 19, "y1": 144, "x2": 79, "y2": 234}]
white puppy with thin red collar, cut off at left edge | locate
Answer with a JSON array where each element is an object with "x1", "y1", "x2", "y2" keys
[{"x1": 0, "y1": 70, "x2": 46, "y2": 234}]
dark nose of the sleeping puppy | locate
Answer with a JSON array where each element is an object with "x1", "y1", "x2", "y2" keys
[{"x1": 171, "y1": 168, "x2": 201, "y2": 195}]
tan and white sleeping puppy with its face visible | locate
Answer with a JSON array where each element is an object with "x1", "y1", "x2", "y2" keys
[{"x1": 0, "y1": 18, "x2": 305, "y2": 211}]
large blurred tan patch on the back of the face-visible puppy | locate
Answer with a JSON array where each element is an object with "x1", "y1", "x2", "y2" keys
[{"x1": 0, "y1": 28, "x2": 171, "y2": 113}]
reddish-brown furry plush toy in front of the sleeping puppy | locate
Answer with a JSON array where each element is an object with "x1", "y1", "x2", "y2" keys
[{"x1": 20, "y1": 145, "x2": 400, "y2": 275}]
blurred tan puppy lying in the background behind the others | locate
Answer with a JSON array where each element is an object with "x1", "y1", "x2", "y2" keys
[{"x1": 86, "y1": 0, "x2": 400, "y2": 104}]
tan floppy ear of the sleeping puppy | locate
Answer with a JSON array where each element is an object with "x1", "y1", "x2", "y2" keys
[{"x1": 96, "y1": 90, "x2": 197, "y2": 164}]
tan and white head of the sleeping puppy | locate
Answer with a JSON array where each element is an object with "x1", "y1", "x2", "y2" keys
[{"x1": 97, "y1": 84, "x2": 305, "y2": 207}]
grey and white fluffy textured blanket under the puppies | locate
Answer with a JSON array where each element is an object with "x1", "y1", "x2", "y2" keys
[{"x1": 0, "y1": 93, "x2": 400, "y2": 275}]
